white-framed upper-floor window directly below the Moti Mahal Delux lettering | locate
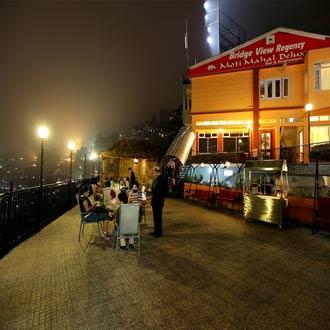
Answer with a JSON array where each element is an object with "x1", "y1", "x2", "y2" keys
[{"x1": 259, "y1": 78, "x2": 289, "y2": 99}]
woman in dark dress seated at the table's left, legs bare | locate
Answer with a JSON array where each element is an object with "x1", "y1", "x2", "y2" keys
[{"x1": 79, "y1": 187, "x2": 114, "y2": 240}]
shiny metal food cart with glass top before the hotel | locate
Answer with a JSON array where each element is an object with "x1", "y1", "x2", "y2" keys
[{"x1": 243, "y1": 159, "x2": 288, "y2": 228}]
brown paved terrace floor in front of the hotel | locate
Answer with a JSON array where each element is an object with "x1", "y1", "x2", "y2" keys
[{"x1": 0, "y1": 199, "x2": 330, "y2": 329}]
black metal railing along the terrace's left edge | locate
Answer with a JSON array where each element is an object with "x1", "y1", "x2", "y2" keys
[{"x1": 0, "y1": 182, "x2": 81, "y2": 258}]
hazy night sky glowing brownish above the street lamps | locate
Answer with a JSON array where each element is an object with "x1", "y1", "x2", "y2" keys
[{"x1": 0, "y1": 0, "x2": 330, "y2": 155}]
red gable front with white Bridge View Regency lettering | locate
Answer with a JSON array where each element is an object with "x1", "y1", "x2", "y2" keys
[{"x1": 188, "y1": 27, "x2": 330, "y2": 78}]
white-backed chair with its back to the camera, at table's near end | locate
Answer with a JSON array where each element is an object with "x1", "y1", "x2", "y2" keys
[{"x1": 116, "y1": 204, "x2": 141, "y2": 257}]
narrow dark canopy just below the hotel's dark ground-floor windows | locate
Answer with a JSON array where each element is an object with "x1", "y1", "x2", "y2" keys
[{"x1": 186, "y1": 152, "x2": 246, "y2": 165}]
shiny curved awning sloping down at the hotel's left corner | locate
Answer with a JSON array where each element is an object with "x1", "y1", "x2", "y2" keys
[{"x1": 163, "y1": 125, "x2": 195, "y2": 165}]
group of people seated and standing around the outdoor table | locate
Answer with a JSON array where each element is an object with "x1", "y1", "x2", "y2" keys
[{"x1": 79, "y1": 167, "x2": 166, "y2": 249}]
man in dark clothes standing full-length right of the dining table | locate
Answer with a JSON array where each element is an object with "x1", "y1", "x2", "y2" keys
[{"x1": 151, "y1": 166, "x2": 167, "y2": 237}]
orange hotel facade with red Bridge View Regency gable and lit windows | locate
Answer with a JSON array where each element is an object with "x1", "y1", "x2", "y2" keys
[{"x1": 184, "y1": 28, "x2": 330, "y2": 163}]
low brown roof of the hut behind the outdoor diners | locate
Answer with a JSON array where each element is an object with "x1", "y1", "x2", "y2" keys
[{"x1": 102, "y1": 139, "x2": 161, "y2": 160}]
